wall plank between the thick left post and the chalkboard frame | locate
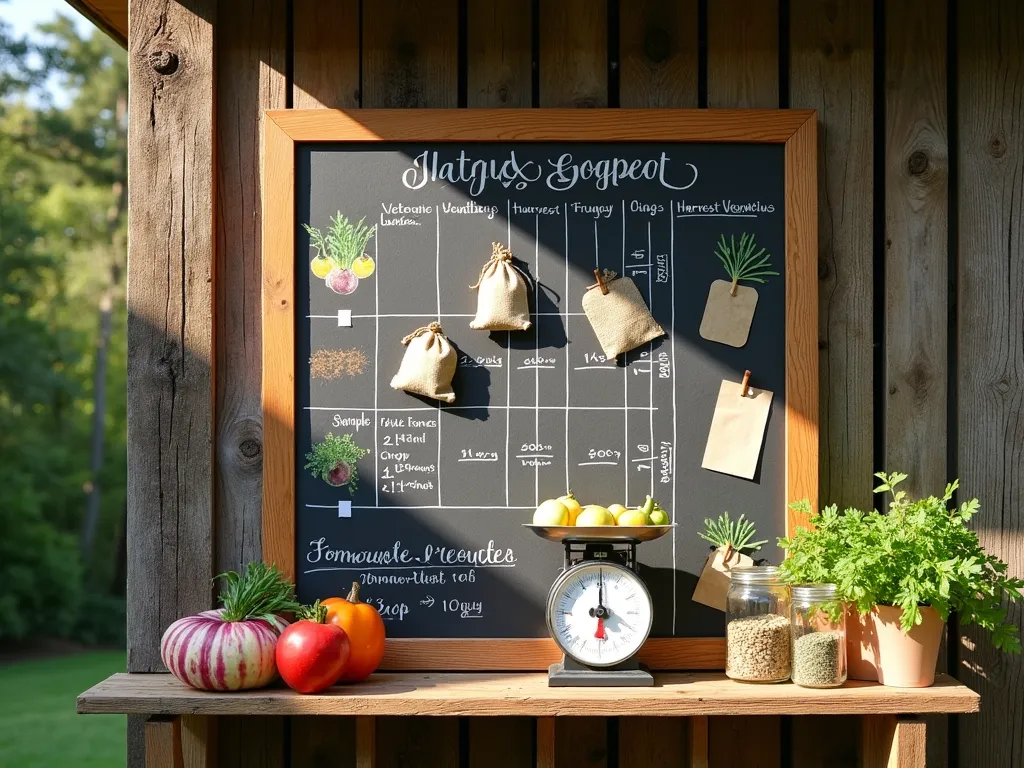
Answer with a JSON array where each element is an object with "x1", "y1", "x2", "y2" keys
[{"x1": 214, "y1": 0, "x2": 288, "y2": 573}]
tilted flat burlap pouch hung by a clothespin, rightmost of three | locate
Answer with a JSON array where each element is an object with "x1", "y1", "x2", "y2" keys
[{"x1": 583, "y1": 269, "x2": 665, "y2": 359}]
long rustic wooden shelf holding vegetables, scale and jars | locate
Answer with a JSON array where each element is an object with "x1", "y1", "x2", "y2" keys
[{"x1": 78, "y1": 673, "x2": 979, "y2": 717}]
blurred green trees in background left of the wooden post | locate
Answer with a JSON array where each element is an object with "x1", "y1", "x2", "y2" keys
[{"x1": 0, "y1": 9, "x2": 127, "y2": 642}]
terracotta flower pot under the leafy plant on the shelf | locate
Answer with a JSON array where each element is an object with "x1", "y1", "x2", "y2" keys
[{"x1": 846, "y1": 605, "x2": 944, "y2": 688}]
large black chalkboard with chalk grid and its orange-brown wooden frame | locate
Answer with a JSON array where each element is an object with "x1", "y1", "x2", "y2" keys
[{"x1": 264, "y1": 111, "x2": 817, "y2": 668}]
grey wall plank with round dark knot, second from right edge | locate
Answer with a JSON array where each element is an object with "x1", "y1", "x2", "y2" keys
[{"x1": 885, "y1": 0, "x2": 948, "y2": 495}]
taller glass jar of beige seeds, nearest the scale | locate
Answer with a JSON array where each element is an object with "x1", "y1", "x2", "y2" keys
[{"x1": 725, "y1": 565, "x2": 793, "y2": 683}]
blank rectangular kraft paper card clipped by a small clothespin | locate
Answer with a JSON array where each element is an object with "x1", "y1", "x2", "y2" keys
[{"x1": 700, "y1": 381, "x2": 772, "y2": 480}]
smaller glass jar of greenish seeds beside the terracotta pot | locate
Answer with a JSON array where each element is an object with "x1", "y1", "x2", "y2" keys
[{"x1": 790, "y1": 584, "x2": 846, "y2": 688}]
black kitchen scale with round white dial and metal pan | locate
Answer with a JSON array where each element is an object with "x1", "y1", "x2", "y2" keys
[{"x1": 525, "y1": 523, "x2": 675, "y2": 687}]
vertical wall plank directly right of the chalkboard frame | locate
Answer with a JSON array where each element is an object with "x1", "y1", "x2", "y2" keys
[{"x1": 790, "y1": 0, "x2": 874, "y2": 514}]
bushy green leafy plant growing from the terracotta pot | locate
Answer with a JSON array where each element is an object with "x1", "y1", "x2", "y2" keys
[{"x1": 779, "y1": 472, "x2": 1024, "y2": 653}]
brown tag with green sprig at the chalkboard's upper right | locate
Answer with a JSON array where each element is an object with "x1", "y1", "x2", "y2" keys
[{"x1": 700, "y1": 232, "x2": 778, "y2": 347}]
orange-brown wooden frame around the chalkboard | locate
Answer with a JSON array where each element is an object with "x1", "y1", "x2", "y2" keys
[{"x1": 262, "y1": 109, "x2": 818, "y2": 671}]
